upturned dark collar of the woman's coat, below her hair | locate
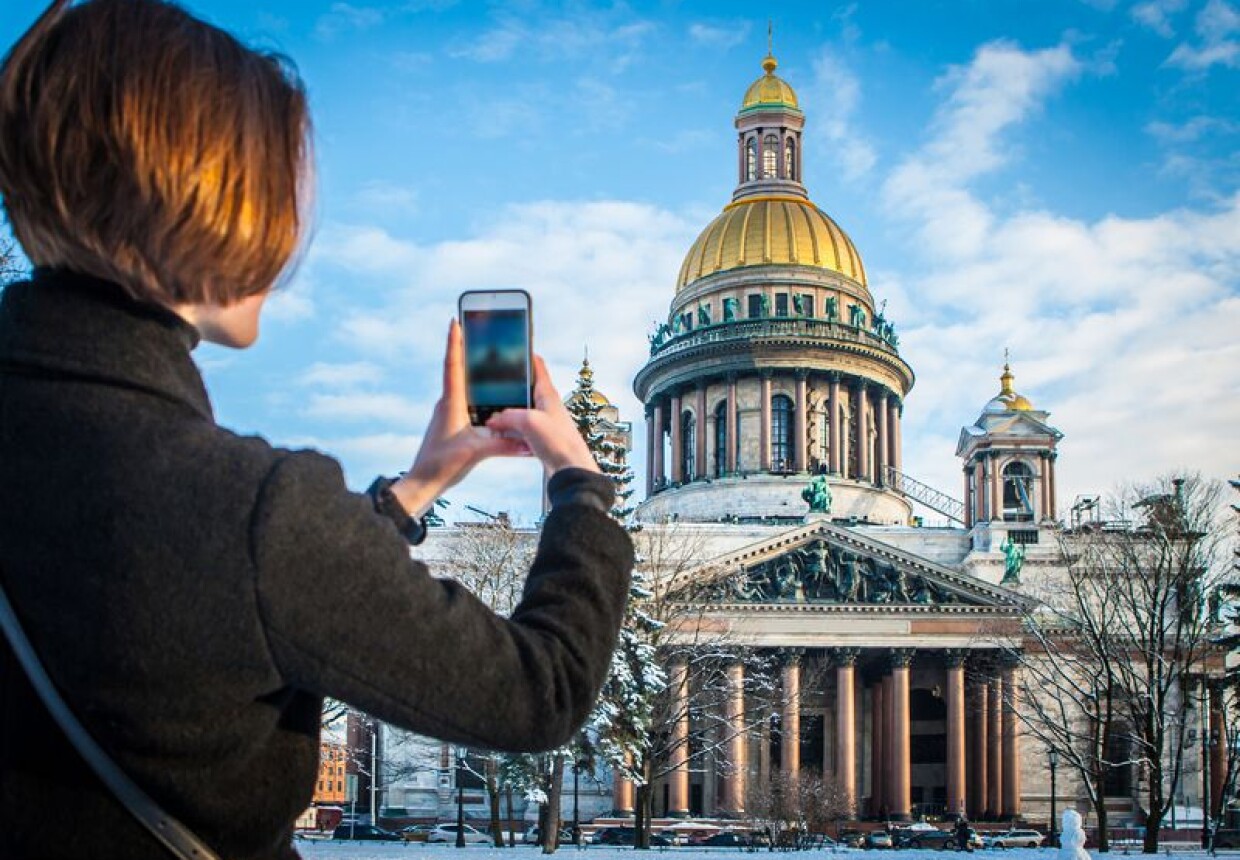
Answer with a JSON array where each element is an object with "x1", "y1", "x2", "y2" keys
[{"x1": 0, "y1": 269, "x2": 215, "y2": 420}]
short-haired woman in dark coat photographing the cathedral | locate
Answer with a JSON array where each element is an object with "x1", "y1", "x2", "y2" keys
[{"x1": 0, "y1": 0, "x2": 632, "y2": 860}]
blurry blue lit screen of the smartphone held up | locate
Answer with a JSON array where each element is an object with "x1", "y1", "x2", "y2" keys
[{"x1": 461, "y1": 309, "x2": 529, "y2": 423}]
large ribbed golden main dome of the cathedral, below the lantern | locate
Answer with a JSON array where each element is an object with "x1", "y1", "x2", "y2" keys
[{"x1": 676, "y1": 195, "x2": 866, "y2": 291}]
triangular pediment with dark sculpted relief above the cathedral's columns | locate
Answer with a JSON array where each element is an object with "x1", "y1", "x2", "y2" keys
[{"x1": 684, "y1": 522, "x2": 1028, "y2": 613}]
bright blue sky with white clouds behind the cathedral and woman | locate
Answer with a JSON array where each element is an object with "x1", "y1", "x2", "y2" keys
[{"x1": 0, "y1": 0, "x2": 1240, "y2": 519}]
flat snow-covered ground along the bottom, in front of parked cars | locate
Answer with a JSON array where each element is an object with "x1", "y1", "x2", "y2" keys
[{"x1": 296, "y1": 840, "x2": 1235, "y2": 860}]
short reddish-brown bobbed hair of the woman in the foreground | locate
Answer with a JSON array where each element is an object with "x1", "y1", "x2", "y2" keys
[{"x1": 0, "y1": 0, "x2": 310, "y2": 305}]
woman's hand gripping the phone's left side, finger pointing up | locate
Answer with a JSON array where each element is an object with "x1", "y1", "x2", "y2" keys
[{"x1": 392, "y1": 320, "x2": 529, "y2": 517}]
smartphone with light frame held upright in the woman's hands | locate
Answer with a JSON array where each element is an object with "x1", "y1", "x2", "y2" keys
[{"x1": 459, "y1": 290, "x2": 533, "y2": 424}]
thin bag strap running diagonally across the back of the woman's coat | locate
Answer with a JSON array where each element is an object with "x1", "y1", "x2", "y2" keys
[{"x1": 0, "y1": 585, "x2": 219, "y2": 860}]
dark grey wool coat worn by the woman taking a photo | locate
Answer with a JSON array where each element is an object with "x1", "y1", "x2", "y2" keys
[{"x1": 0, "y1": 271, "x2": 632, "y2": 860}]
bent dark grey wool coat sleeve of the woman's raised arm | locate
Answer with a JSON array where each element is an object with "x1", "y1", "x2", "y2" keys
[{"x1": 250, "y1": 451, "x2": 634, "y2": 751}]
